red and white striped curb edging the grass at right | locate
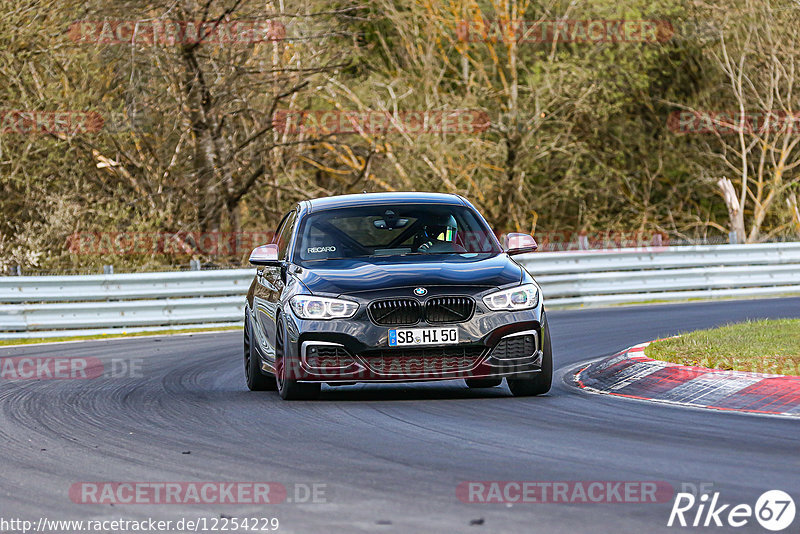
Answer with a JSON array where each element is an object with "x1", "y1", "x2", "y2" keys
[{"x1": 575, "y1": 342, "x2": 800, "y2": 418}]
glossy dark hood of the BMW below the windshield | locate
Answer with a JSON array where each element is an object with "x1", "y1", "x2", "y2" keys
[{"x1": 294, "y1": 254, "x2": 522, "y2": 295}]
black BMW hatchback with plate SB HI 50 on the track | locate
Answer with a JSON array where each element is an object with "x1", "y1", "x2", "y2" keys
[{"x1": 244, "y1": 193, "x2": 553, "y2": 399}]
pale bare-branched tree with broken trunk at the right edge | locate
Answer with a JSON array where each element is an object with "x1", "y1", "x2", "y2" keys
[{"x1": 680, "y1": 0, "x2": 800, "y2": 243}]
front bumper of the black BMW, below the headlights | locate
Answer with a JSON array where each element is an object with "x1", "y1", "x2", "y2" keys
[{"x1": 283, "y1": 303, "x2": 543, "y2": 383}]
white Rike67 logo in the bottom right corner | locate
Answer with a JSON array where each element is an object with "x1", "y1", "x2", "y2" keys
[{"x1": 667, "y1": 490, "x2": 795, "y2": 532}]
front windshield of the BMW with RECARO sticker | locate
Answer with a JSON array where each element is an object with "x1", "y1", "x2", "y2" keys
[{"x1": 295, "y1": 204, "x2": 501, "y2": 264}]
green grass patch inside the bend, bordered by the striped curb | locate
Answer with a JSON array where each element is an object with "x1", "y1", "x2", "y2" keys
[{"x1": 645, "y1": 319, "x2": 800, "y2": 376}]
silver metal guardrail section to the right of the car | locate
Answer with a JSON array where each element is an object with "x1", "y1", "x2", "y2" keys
[{"x1": 520, "y1": 243, "x2": 800, "y2": 307}]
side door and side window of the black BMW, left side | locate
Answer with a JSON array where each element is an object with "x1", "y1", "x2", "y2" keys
[{"x1": 253, "y1": 210, "x2": 297, "y2": 364}]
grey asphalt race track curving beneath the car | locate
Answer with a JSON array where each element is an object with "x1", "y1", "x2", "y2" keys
[{"x1": 0, "y1": 298, "x2": 800, "y2": 534}]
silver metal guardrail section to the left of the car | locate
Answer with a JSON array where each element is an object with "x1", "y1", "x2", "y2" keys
[{"x1": 0, "y1": 269, "x2": 255, "y2": 339}]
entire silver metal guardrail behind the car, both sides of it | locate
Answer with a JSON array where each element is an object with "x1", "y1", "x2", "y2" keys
[{"x1": 0, "y1": 243, "x2": 800, "y2": 339}]
